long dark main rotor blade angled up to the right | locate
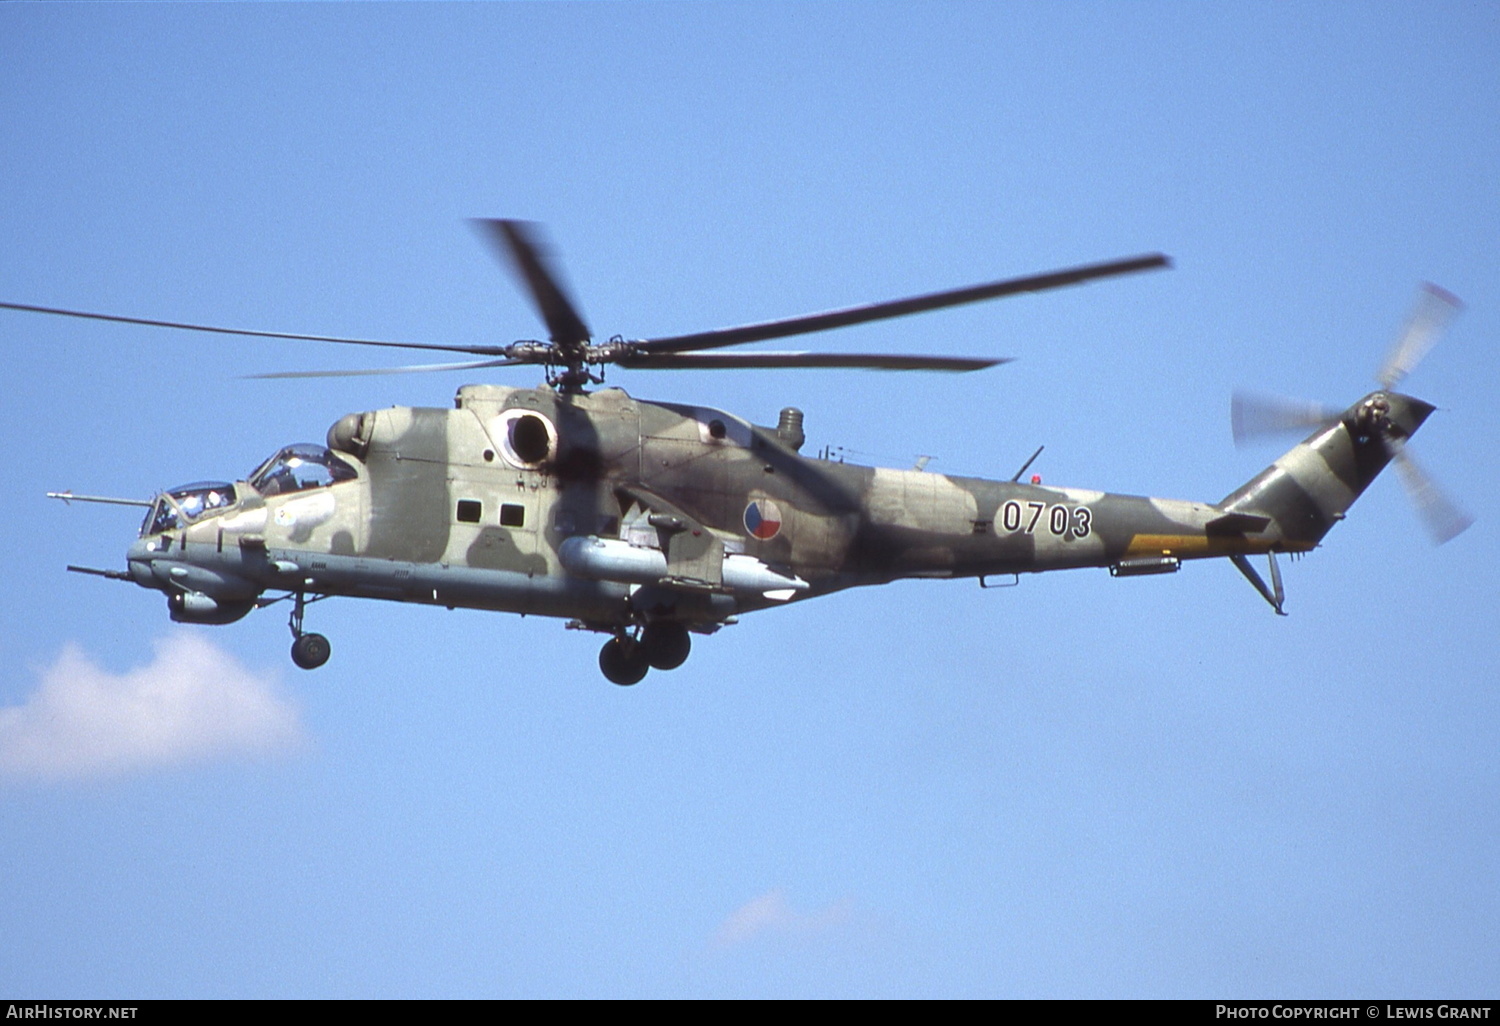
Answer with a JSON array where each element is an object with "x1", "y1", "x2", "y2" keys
[{"x1": 636, "y1": 254, "x2": 1170, "y2": 353}]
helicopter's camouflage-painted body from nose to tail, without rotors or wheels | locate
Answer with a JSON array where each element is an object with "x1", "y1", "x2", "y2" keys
[{"x1": 128, "y1": 386, "x2": 1433, "y2": 635}]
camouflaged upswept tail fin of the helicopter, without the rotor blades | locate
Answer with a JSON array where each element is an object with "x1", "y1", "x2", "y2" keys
[{"x1": 1220, "y1": 392, "x2": 1434, "y2": 552}]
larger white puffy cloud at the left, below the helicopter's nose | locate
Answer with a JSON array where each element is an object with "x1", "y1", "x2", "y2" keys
[{"x1": 0, "y1": 632, "x2": 305, "y2": 780}]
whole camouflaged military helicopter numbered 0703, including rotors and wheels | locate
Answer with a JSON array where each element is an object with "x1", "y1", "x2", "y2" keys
[{"x1": 0, "y1": 221, "x2": 1467, "y2": 684}]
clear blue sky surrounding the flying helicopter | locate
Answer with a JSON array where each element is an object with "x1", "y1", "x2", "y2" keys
[{"x1": 0, "y1": 3, "x2": 1500, "y2": 998}]
